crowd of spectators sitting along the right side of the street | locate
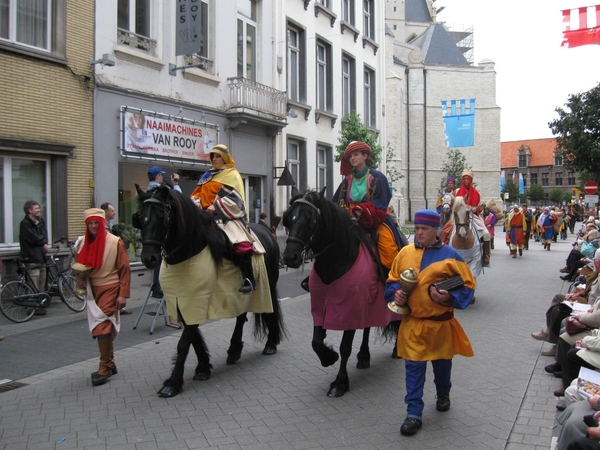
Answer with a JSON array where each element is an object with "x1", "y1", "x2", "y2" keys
[{"x1": 531, "y1": 208, "x2": 600, "y2": 450}]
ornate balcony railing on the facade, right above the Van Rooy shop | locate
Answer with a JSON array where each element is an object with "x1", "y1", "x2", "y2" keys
[{"x1": 227, "y1": 77, "x2": 287, "y2": 120}]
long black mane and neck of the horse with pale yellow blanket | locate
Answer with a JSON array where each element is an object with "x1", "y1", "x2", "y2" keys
[{"x1": 138, "y1": 184, "x2": 226, "y2": 265}]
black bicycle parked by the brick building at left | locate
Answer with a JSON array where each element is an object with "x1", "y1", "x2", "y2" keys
[{"x1": 0, "y1": 238, "x2": 86, "y2": 323}]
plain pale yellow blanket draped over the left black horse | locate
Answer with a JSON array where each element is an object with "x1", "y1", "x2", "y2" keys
[{"x1": 160, "y1": 248, "x2": 273, "y2": 325}]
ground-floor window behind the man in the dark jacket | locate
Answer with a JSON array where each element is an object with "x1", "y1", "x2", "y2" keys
[{"x1": 0, "y1": 155, "x2": 51, "y2": 244}]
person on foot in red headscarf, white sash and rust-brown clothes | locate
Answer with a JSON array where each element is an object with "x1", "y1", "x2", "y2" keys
[{"x1": 76, "y1": 208, "x2": 131, "y2": 386}]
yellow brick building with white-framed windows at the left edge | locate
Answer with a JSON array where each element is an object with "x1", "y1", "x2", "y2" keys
[{"x1": 0, "y1": 0, "x2": 94, "y2": 259}]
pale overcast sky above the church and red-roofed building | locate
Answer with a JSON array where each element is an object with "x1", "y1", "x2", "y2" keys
[{"x1": 434, "y1": 0, "x2": 600, "y2": 142}]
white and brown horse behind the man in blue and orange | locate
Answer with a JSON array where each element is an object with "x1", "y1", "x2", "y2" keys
[{"x1": 449, "y1": 197, "x2": 483, "y2": 277}]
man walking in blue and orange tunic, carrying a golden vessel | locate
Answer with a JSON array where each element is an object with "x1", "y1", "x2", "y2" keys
[{"x1": 385, "y1": 209, "x2": 475, "y2": 435}]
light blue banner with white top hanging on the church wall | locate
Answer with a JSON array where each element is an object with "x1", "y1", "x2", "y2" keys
[{"x1": 442, "y1": 98, "x2": 475, "y2": 148}]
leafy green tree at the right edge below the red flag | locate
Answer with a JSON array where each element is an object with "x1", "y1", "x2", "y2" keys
[{"x1": 548, "y1": 83, "x2": 600, "y2": 181}]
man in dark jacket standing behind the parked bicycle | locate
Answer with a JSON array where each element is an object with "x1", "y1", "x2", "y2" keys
[{"x1": 19, "y1": 200, "x2": 50, "y2": 316}]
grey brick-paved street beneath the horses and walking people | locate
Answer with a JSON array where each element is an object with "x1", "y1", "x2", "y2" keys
[{"x1": 0, "y1": 232, "x2": 571, "y2": 450}]
